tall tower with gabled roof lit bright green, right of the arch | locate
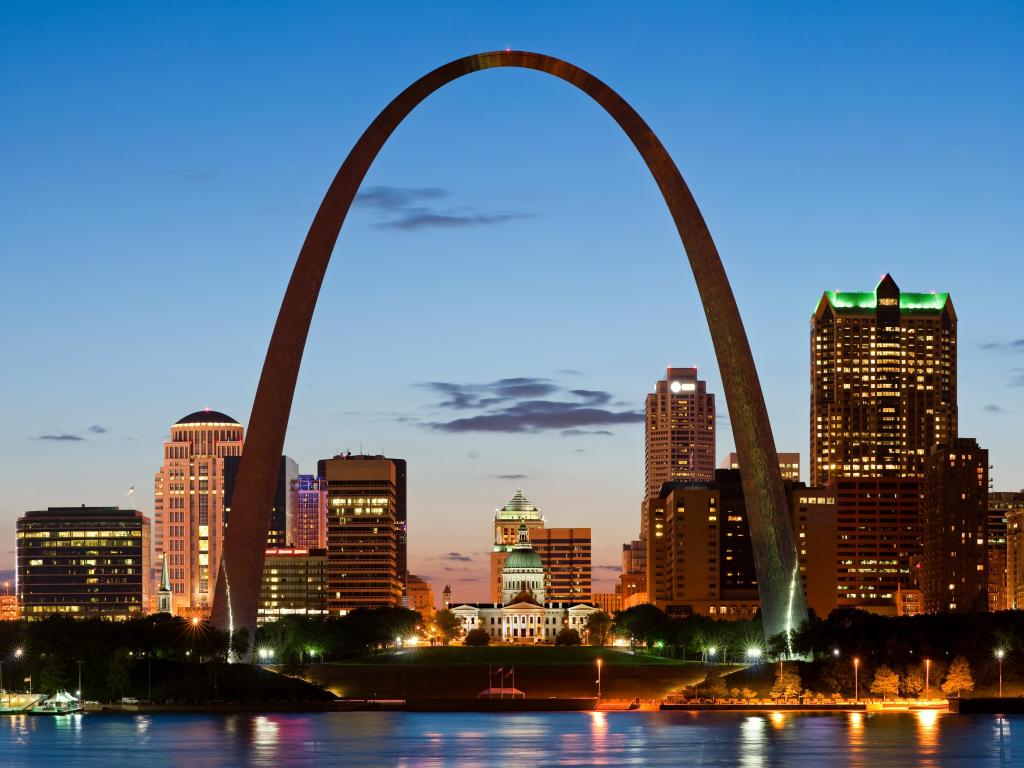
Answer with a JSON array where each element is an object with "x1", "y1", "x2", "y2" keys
[{"x1": 810, "y1": 274, "x2": 956, "y2": 485}]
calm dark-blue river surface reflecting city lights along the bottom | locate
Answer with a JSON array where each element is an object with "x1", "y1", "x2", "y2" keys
[{"x1": 0, "y1": 712, "x2": 1024, "y2": 768}]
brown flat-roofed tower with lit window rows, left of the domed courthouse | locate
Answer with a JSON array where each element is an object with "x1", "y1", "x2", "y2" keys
[{"x1": 316, "y1": 454, "x2": 402, "y2": 615}]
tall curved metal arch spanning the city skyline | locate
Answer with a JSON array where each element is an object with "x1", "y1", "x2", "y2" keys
[{"x1": 213, "y1": 51, "x2": 807, "y2": 651}]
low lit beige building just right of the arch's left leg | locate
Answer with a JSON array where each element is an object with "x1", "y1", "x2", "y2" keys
[{"x1": 256, "y1": 547, "x2": 327, "y2": 624}]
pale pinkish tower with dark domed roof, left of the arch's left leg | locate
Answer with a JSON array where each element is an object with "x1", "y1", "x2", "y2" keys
[{"x1": 154, "y1": 410, "x2": 244, "y2": 612}]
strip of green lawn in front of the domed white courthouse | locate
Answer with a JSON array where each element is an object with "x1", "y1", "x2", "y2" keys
[{"x1": 327, "y1": 645, "x2": 693, "y2": 667}]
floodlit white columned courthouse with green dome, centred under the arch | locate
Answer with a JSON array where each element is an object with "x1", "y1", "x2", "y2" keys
[{"x1": 452, "y1": 522, "x2": 597, "y2": 643}]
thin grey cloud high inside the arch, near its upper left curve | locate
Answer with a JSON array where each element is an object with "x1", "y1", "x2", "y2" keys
[{"x1": 355, "y1": 185, "x2": 534, "y2": 231}]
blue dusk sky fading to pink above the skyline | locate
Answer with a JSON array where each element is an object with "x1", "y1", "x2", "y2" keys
[{"x1": 0, "y1": 2, "x2": 1024, "y2": 599}]
